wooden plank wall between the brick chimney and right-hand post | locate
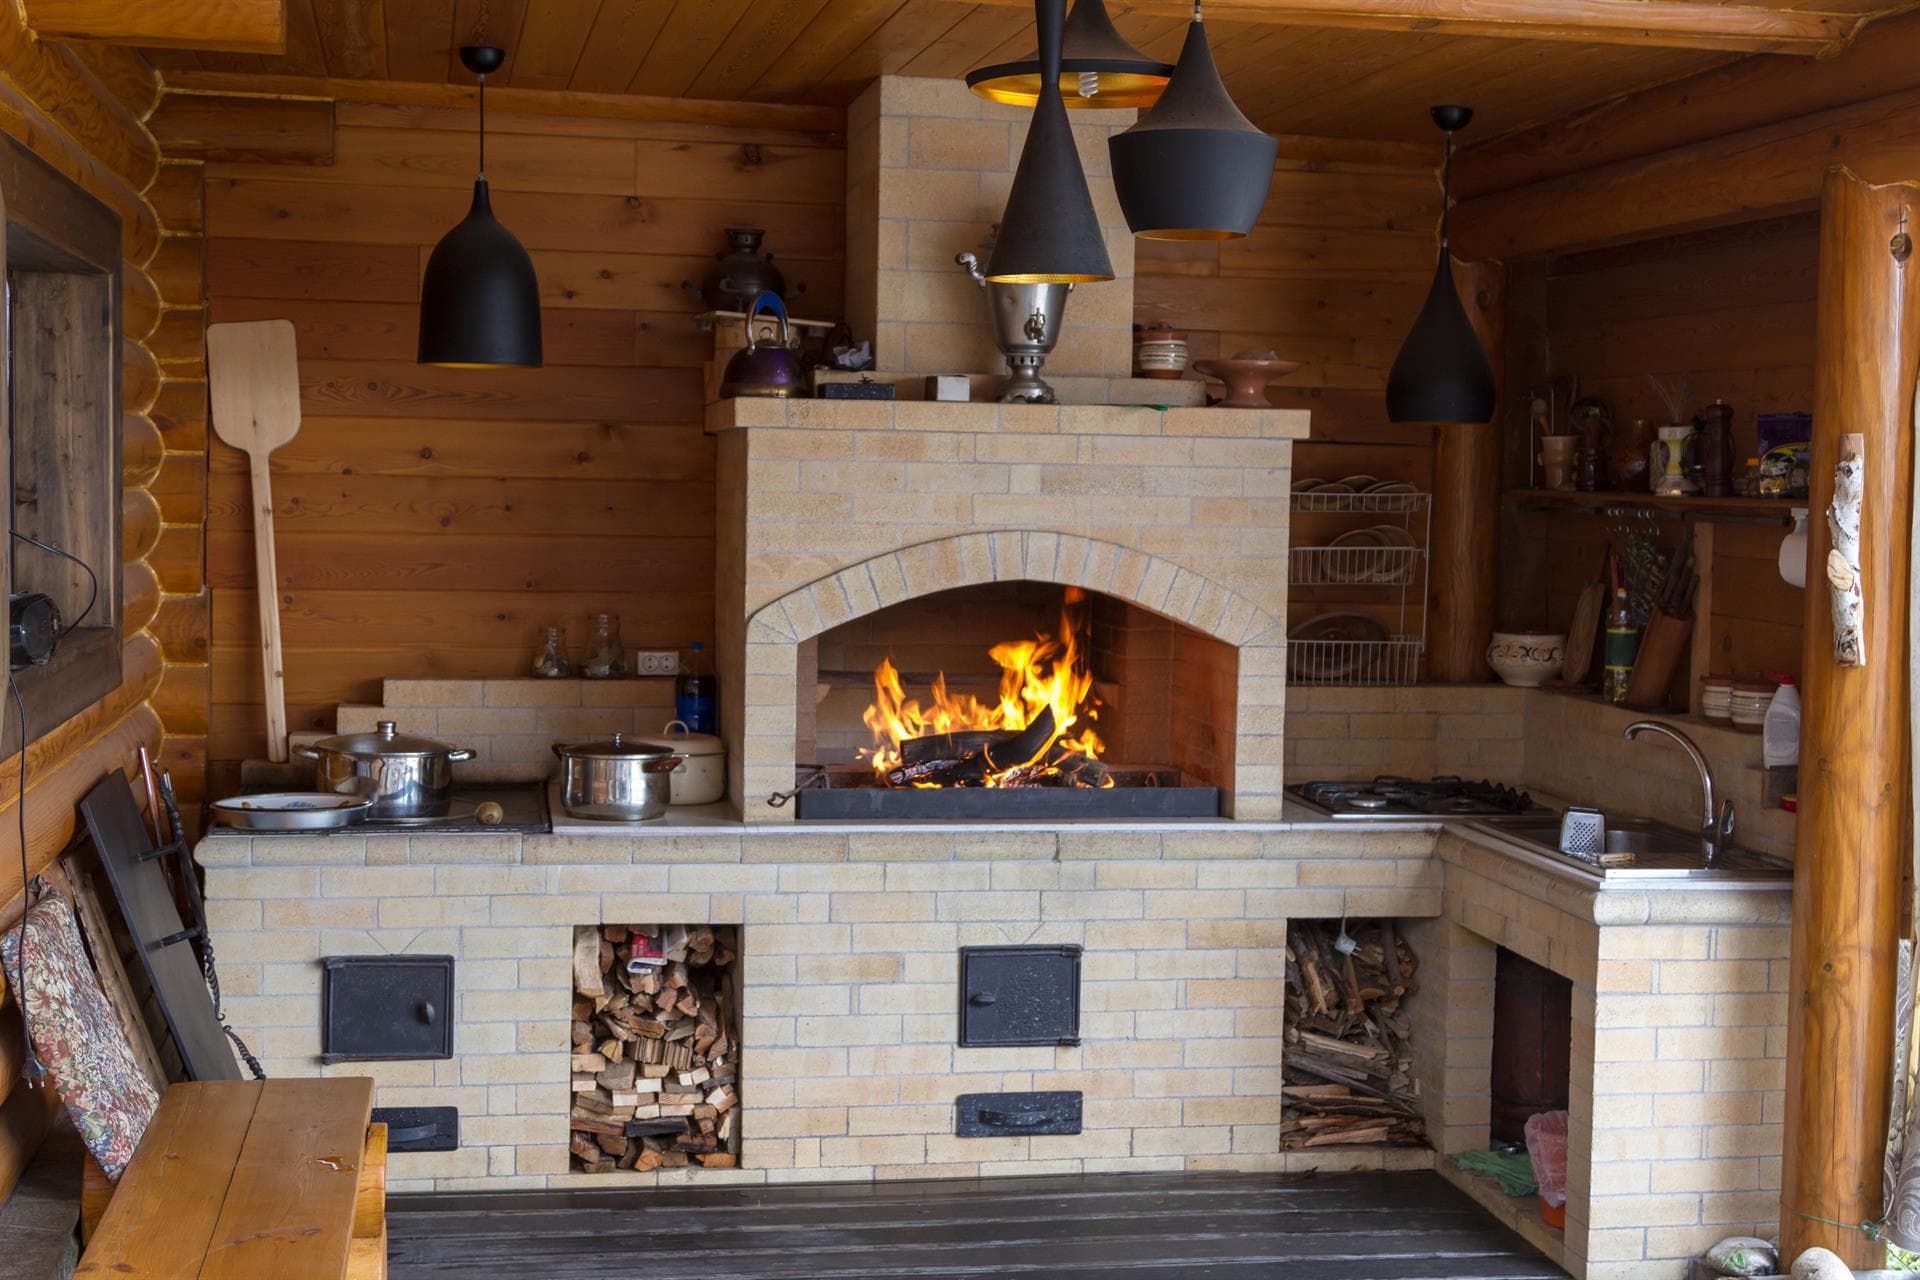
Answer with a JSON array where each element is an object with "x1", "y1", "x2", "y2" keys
[{"x1": 1135, "y1": 138, "x2": 1440, "y2": 656}]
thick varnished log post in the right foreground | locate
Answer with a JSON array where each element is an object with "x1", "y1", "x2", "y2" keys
[{"x1": 1780, "y1": 169, "x2": 1920, "y2": 1268}]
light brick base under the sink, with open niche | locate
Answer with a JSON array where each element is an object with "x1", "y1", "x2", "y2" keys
[{"x1": 1415, "y1": 835, "x2": 1791, "y2": 1280}]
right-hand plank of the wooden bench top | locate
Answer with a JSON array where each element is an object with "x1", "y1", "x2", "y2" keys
[{"x1": 202, "y1": 1077, "x2": 372, "y2": 1280}]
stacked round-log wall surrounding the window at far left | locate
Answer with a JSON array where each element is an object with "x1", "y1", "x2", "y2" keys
[{"x1": 0, "y1": 17, "x2": 207, "y2": 1199}]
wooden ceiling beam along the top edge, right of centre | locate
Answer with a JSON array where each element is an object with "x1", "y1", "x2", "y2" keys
[{"x1": 981, "y1": 0, "x2": 1864, "y2": 56}]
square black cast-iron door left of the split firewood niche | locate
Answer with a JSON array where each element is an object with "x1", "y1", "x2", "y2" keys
[{"x1": 321, "y1": 956, "x2": 453, "y2": 1063}]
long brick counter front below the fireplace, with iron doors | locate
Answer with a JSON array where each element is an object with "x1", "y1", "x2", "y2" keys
[{"x1": 198, "y1": 825, "x2": 1440, "y2": 1190}]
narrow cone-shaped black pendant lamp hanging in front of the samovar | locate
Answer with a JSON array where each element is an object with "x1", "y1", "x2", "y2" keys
[{"x1": 987, "y1": 0, "x2": 1114, "y2": 284}]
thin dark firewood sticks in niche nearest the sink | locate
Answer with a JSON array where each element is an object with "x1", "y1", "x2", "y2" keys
[{"x1": 1281, "y1": 919, "x2": 1427, "y2": 1150}]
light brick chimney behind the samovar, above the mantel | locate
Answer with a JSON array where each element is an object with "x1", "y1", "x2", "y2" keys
[{"x1": 847, "y1": 75, "x2": 1135, "y2": 376}]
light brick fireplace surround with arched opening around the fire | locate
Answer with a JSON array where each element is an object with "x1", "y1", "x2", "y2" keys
[{"x1": 707, "y1": 399, "x2": 1308, "y2": 821}]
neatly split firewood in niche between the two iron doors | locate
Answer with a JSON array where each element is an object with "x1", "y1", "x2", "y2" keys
[{"x1": 568, "y1": 925, "x2": 739, "y2": 1173}]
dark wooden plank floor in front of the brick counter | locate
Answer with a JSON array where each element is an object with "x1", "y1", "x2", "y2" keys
[{"x1": 388, "y1": 1173, "x2": 1565, "y2": 1280}]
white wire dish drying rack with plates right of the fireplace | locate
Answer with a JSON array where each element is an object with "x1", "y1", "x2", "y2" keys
[{"x1": 1286, "y1": 491, "x2": 1432, "y2": 685}]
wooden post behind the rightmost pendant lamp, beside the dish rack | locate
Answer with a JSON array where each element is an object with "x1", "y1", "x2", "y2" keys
[{"x1": 1427, "y1": 263, "x2": 1507, "y2": 683}]
